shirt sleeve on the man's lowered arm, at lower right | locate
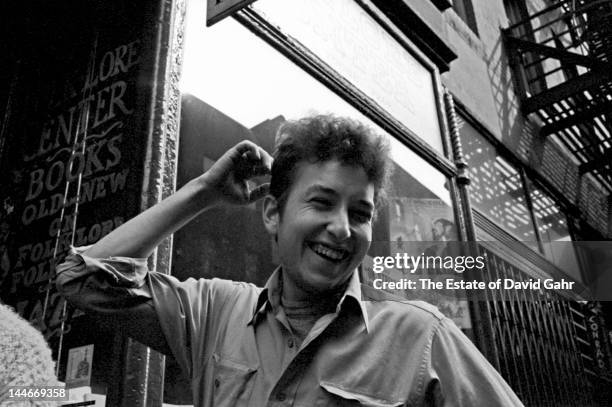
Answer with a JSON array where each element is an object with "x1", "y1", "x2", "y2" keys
[{"x1": 427, "y1": 318, "x2": 523, "y2": 407}]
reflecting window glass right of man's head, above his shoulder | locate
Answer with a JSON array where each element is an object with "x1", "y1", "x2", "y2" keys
[{"x1": 362, "y1": 139, "x2": 471, "y2": 335}]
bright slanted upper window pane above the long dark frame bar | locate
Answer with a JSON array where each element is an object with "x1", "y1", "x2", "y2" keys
[{"x1": 252, "y1": 0, "x2": 444, "y2": 154}]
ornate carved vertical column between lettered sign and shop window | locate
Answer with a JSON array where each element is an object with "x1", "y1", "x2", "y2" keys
[{"x1": 116, "y1": 0, "x2": 185, "y2": 407}]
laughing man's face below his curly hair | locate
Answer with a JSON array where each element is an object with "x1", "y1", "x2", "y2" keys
[{"x1": 264, "y1": 160, "x2": 374, "y2": 300}]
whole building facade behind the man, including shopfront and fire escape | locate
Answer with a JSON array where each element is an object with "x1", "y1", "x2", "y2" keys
[{"x1": 0, "y1": 0, "x2": 612, "y2": 406}]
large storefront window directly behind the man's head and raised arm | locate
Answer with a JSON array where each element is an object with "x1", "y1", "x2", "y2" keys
[{"x1": 166, "y1": 2, "x2": 462, "y2": 402}]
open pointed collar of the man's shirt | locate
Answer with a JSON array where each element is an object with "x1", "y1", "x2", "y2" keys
[{"x1": 248, "y1": 267, "x2": 370, "y2": 332}]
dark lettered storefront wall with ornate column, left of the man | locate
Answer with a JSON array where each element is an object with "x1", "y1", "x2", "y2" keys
[{"x1": 0, "y1": 0, "x2": 184, "y2": 407}]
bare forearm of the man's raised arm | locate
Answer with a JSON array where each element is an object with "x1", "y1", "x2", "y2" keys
[{"x1": 85, "y1": 177, "x2": 215, "y2": 258}]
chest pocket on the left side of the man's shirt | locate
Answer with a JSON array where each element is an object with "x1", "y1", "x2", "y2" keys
[{"x1": 212, "y1": 353, "x2": 257, "y2": 407}]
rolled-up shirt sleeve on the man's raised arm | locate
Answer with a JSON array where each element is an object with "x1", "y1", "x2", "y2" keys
[{"x1": 56, "y1": 247, "x2": 246, "y2": 379}]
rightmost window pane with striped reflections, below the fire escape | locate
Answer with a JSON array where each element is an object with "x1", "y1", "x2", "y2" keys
[{"x1": 529, "y1": 183, "x2": 582, "y2": 281}]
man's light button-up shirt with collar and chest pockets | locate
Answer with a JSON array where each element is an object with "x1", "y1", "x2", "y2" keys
[{"x1": 57, "y1": 250, "x2": 522, "y2": 407}]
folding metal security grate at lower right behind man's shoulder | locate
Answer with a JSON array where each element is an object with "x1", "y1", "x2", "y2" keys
[{"x1": 481, "y1": 246, "x2": 597, "y2": 407}]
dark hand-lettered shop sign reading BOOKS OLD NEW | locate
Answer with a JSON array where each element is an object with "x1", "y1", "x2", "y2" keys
[{"x1": 0, "y1": 31, "x2": 144, "y2": 348}]
